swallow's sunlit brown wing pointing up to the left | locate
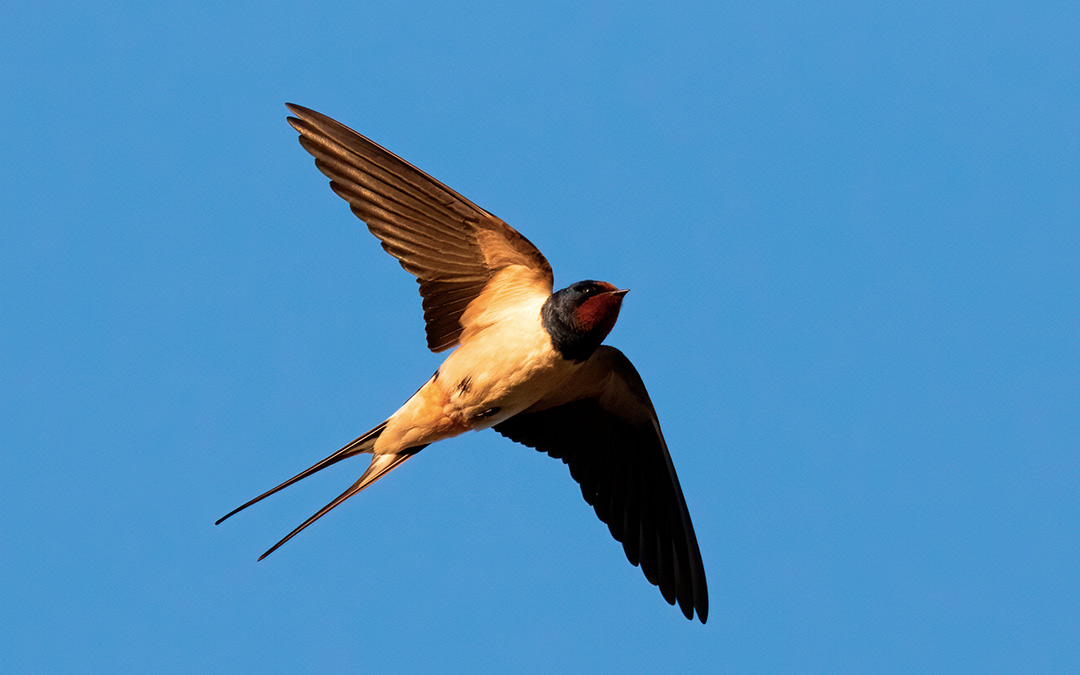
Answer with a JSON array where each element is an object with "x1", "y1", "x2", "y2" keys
[{"x1": 286, "y1": 104, "x2": 554, "y2": 352}]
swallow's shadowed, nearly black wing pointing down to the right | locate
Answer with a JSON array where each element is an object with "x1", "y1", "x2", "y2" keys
[{"x1": 495, "y1": 347, "x2": 708, "y2": 623}]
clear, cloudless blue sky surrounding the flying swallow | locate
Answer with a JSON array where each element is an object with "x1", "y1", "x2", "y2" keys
[{"x1": 0, "y1": 0, "x2": 1080, "y2": 673}]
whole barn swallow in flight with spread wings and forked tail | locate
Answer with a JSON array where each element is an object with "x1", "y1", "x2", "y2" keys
[{"x1": 217, "y1": 104, "x2": 708, "y2": 623}]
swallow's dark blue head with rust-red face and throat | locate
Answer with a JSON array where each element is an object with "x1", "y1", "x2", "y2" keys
[{"x1": 540, "y1": 280, "x2": 626, "y2": 362}]
